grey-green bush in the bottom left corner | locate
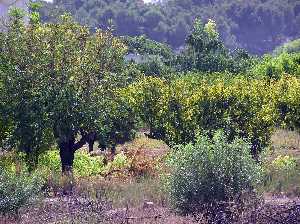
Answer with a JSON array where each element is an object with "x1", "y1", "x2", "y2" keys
[{"x1": 0, "y1": 167, "x2": 43, "y2": 214}]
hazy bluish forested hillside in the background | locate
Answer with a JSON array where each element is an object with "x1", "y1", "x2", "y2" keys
[{"x1": 41, "y1": 0, "x2": 300, "y2": 55}]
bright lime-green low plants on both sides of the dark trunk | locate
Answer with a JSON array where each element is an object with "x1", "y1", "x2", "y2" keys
[{"x1": 38, "y1": 150, "x2": 104, "y2": 177}]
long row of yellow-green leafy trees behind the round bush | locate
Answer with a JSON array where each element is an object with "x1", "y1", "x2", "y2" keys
[{"x1": 125, "y1": 76, "x2": 300, "y2": 154}]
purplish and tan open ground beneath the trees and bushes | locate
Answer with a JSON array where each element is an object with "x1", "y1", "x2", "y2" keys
[{"x1": 0, "y1": 132, "x2": 300, "y2": 224}]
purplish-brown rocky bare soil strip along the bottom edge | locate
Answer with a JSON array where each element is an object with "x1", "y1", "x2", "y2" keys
[{"x1": 0, "y1": 195, "x2": 300, "y2": 224}]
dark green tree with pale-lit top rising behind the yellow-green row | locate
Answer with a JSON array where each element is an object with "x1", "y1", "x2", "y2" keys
[{"x1": 176, "y1": 19, "x2": 254, "y2": 74}]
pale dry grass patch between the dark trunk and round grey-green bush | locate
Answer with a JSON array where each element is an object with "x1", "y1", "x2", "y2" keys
[{"x1": 75, "y1": 177, "x2": 166, "y2": 208}]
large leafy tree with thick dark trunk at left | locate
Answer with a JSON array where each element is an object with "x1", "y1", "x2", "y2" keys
[{"x1": 0, "y1": 10, "x2": 134, "y2": 172}]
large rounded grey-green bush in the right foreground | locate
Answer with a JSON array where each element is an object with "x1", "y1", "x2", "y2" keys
[{"x1": 163, "y1": 131, "x2": 262, "y2": 213}]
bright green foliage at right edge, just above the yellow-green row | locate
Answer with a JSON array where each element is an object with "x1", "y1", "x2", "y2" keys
[{"x1": 250, "y1": 53, "x2": 300, "y2": 79}]
